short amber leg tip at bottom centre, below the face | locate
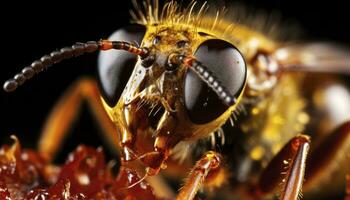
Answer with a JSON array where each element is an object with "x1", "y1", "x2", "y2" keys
[{"x1": 177, "y1": 151, "x2": 221, "y2": 200}]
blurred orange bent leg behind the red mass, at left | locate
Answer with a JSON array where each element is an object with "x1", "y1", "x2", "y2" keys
[{"x1": 38, "y1": 78, "x2": 118, "y2": 160}]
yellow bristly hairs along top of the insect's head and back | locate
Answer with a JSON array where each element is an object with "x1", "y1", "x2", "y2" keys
[{"x1": 130, "y1": 0, "x2": 302, "y2": 42}]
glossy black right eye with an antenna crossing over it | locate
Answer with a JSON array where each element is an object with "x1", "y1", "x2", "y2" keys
[{"x1": 184, "y1": 39, "x2": 247, "y2": 124}]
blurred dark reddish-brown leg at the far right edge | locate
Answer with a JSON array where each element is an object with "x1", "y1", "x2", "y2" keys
[{"x1": 305, "y1": 121, "x2": 350, "y2": 189}]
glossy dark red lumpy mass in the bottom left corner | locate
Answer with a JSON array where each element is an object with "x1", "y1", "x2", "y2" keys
[{"x1": 0, "y1": 137, "x2": 155, "y2": 200}]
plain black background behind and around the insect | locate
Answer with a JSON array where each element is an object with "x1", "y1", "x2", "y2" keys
[{"x1": 0, "y1": 0, "x2": 350, "y2": 157}]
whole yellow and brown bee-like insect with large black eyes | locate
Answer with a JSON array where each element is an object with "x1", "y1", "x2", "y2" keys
[{"x1": 4, "y1": 0, "x2": 350, "y2": 199}]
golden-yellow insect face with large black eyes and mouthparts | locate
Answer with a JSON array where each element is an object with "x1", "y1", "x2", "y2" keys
[{"x1": 99, "y1": 24, "x2": 246, "y2": 166}]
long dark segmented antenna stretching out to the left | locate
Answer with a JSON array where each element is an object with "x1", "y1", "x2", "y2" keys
[{"x1": 3, "y1": 40, "x2": 148, "y2": 92}]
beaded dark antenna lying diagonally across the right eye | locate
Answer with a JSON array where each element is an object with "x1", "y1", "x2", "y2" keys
[{"x1": 178, "y1": 55, "x2": 237, "y2": 106}]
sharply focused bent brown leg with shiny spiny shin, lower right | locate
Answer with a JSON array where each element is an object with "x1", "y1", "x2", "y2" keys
[{"x1": 255, "y1": 135, "x2": 310, "y2": 199}]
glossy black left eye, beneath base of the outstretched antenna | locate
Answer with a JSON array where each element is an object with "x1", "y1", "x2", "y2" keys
[{"x1": 98, "y1": 25, "x2": 146, "y2": 107}]
